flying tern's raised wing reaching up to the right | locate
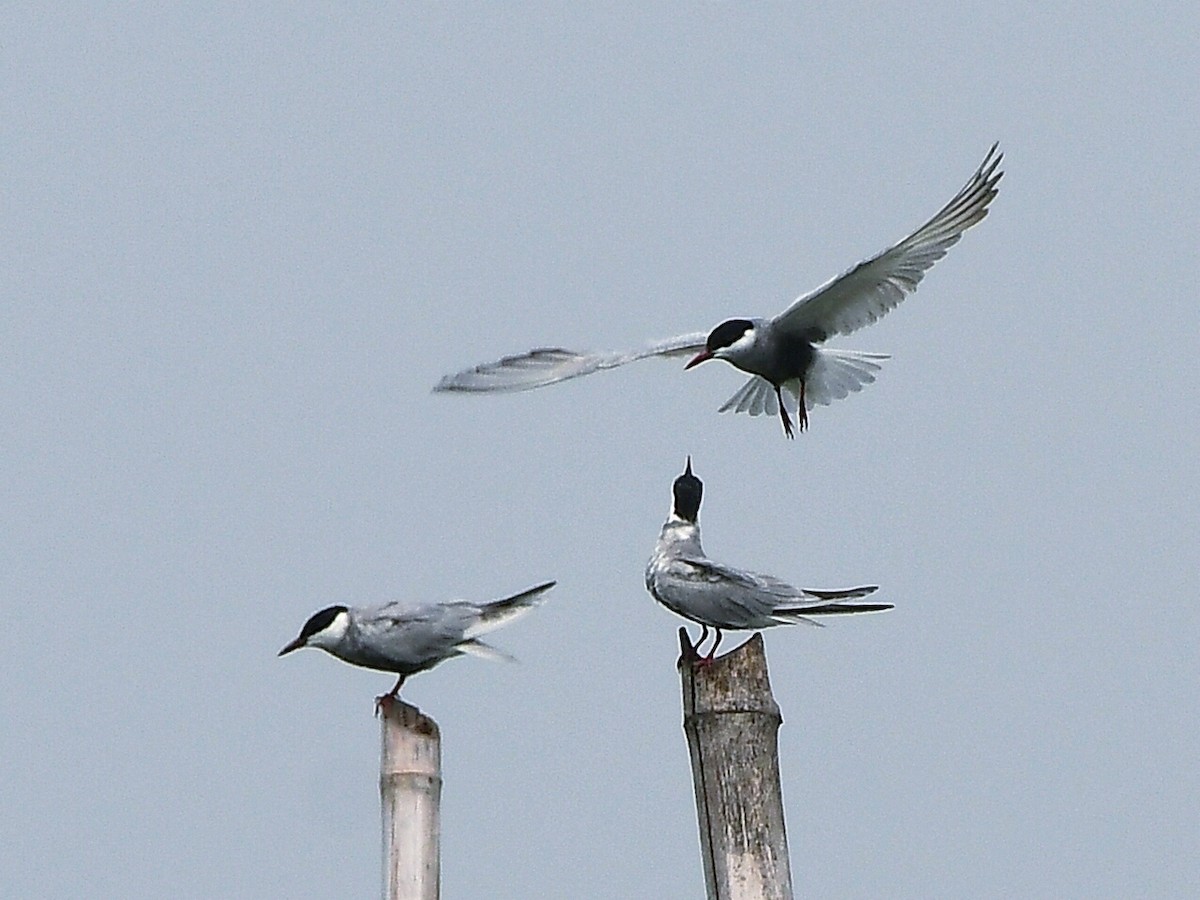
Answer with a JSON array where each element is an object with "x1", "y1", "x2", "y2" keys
[{"x1": 774, "y1": 144, "x2": 1004, "y2": 341}]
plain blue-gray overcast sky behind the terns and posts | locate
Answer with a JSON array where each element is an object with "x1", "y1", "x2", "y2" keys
[{"x1": 0, "y1": 1, "x2": 1200, "y2": 900}]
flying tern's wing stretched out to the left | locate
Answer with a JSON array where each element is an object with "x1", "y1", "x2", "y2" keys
[{"x1": 433, "y1": 331, "x2": 708, "y2": 392}]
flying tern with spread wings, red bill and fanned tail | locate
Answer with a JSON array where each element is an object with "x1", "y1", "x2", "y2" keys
[{"x1": 433, "y1": 144, "x2": 1003, "y2": 438}]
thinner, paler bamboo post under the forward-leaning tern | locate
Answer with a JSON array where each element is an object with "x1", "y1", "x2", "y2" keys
[{"x1": 379, "y1": 697, "x2": 442, "y2": 900}]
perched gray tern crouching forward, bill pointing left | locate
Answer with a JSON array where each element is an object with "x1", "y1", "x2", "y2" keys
[{"x1": 278, "y1": 581, "x2": 557, "y2": 702}]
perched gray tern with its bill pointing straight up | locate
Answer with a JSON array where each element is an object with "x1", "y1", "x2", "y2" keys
[{"x1": 646, "y1": 456, "x2": 893, "y2": 665}]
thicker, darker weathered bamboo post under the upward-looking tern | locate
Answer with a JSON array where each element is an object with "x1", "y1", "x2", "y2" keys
[{"x1": 678, "y1": 628, "x2": 792, "y2": 900}]
